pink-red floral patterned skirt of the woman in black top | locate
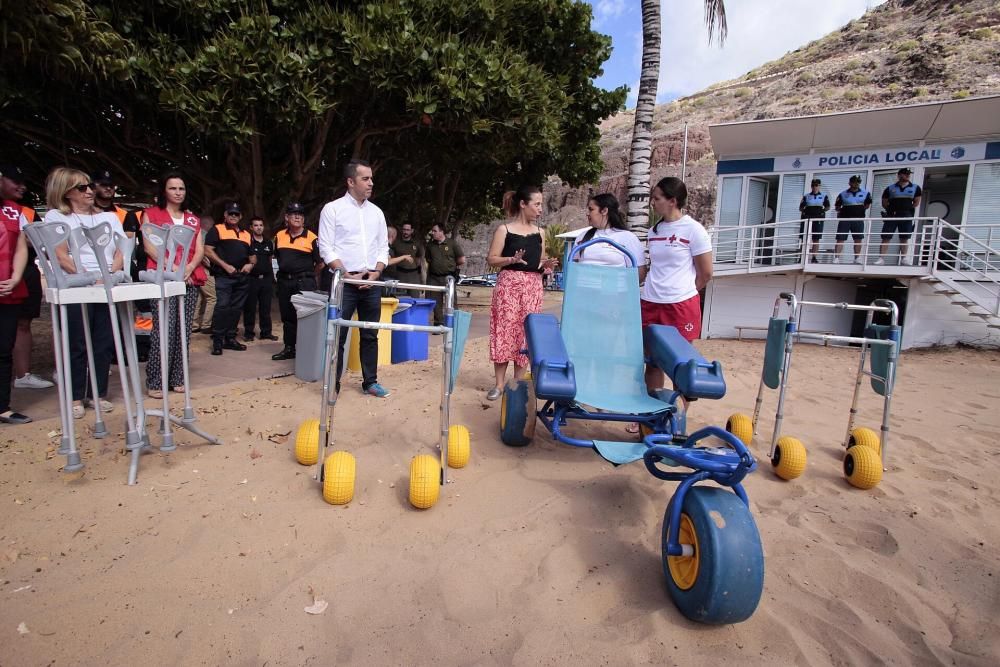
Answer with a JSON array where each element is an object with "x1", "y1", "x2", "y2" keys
[{"x1": 490, "y1": 271, "x2": 542, "y2": 367}]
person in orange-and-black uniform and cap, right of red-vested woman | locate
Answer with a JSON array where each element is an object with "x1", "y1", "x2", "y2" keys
[{"x1": 205, "y1": 202, "x2": 257, "y2": 356}]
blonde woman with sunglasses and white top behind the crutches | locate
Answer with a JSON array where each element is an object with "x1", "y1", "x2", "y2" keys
[{"x1": 44, "y1": 167, "x2": 125, "y2": 419}]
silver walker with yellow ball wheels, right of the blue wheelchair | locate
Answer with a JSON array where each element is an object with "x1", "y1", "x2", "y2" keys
[{"x1": 726, "y1": 293, "x2": 900, "y2": 489}]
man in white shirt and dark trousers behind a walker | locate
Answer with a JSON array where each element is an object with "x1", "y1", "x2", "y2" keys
[{"x1": 319, "y1": 160, "x2": 389, "y2": 398}]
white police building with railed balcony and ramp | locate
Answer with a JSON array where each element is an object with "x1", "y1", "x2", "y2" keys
[{"x1": 703, "y1": 96, "x2": 1000, "y2": 349}]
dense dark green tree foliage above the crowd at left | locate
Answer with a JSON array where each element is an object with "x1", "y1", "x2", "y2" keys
[{"x1": 0, "y1": 0, "x2": 625, "y2": 228}]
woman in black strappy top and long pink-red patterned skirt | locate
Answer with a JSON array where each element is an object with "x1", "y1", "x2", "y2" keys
[{"x1": 486, "y1": 185, "x2": 559, "y2": 401}]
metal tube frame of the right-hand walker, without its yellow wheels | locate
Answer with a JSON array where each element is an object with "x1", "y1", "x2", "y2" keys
[{"x1": 753, "y1": 292, "x2": 899, "y2": 469}]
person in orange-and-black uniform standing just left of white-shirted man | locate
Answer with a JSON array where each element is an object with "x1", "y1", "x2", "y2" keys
[{"x1": 271, "y1": 202, "x2": 323, "y2": 361}]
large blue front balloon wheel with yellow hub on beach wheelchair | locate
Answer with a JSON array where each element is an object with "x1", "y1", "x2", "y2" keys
[{"x1": 661, "y1": 486, "x2": 764, "y2": 625}]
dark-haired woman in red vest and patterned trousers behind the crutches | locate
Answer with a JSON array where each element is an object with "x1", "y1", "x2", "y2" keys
[{"x1": 142, "y1": 171, "x2": 206, "y2": 398}]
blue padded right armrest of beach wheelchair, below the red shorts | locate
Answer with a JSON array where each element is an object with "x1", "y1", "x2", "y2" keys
[{"x1": 642, "y1": 324, "x2": 726, "y2": 399}]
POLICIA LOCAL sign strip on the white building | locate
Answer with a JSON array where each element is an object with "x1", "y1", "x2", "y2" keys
[{"x1": 774, "y1": 142, "x2": 987, "y2": 171}]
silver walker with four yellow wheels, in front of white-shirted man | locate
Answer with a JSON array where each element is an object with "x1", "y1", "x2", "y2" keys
[{"x1": 295, "y1": 270, "x2": 471, "y2": 509}]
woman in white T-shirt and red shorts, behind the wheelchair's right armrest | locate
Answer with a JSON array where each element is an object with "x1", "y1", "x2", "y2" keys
[{"x1": 641, "y1": 177, "x2": 712, "y2": 389}]
